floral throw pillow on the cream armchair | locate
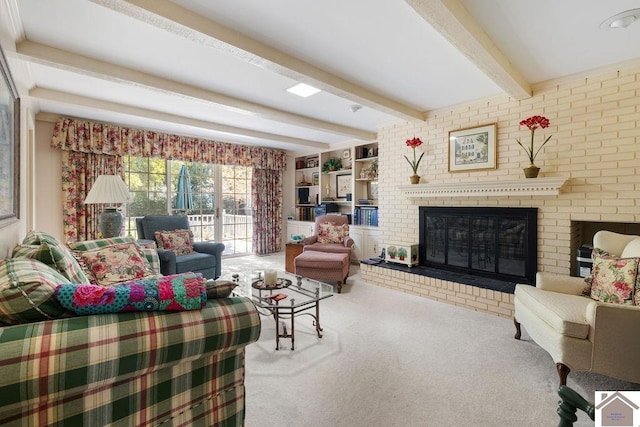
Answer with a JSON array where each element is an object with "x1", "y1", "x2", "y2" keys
[{"x1": 591, "y1": 253, "x2": 640, "y2": 305}]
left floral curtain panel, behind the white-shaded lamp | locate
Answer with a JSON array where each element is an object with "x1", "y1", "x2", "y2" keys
[{"x1": 62, "y1": 151, "x2": 124, "y2": 242}]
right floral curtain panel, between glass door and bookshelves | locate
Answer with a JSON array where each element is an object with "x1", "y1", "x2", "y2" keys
[{"x1": 251, "y1": 169, "x2": 282, "y2": 255}]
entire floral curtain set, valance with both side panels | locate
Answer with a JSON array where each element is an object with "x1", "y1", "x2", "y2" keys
[{"x1": 51, "y1": 117, "x2": 286, "y2": 254}]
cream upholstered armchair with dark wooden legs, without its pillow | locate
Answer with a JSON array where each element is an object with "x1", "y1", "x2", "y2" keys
[{"x1": 514, "y1": 231, "x2": 640, "y2": 385}]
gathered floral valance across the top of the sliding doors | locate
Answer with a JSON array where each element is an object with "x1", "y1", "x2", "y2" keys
[{"x1": 51, "y1": 117, "x2": 286, "y2": 170}]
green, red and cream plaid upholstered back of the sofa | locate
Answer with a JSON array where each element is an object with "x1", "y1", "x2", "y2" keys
[{"x1": 0, "y1": 298, "x2": 260, "y2": 427}]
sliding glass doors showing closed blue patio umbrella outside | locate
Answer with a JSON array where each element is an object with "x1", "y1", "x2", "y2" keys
[{"x1": 125, "y1": 157, "x2": 253, "y2": 255}]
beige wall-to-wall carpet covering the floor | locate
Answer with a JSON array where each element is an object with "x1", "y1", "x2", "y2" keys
[{"x1": 223, "y1": 254, "x2": 640, "y2": 427}]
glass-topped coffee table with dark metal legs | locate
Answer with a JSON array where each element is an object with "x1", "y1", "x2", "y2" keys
[{"x1": 222, "y1": 270, "x2": 333, "y2": 350}]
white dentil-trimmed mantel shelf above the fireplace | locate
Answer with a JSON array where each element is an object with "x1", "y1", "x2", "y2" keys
[{"x1": 398, "y1": 177, "x2": 568, "y2": 199}]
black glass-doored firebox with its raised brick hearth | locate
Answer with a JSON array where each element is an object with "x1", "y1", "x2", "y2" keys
[{"x1": 360, "y1": 206, "x2": 538, "y2": 317}]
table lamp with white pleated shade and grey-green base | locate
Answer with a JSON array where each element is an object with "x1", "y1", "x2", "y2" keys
[{"x1": 84, "y1": 175, "x2": 133, "y2": 237}]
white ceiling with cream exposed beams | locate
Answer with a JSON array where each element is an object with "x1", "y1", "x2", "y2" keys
[{"x1": 0, "y1": 0, "x2": 640, "y2": 152}]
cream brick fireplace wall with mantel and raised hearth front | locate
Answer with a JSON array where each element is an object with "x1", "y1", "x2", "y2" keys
[{"x1": 361, "y1": 63, "x2": 640, "y2": 317}]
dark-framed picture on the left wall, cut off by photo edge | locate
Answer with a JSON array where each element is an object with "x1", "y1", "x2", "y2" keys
[{"x1": 0, "y1": 44, "x2": 20, "y2": 227}]
